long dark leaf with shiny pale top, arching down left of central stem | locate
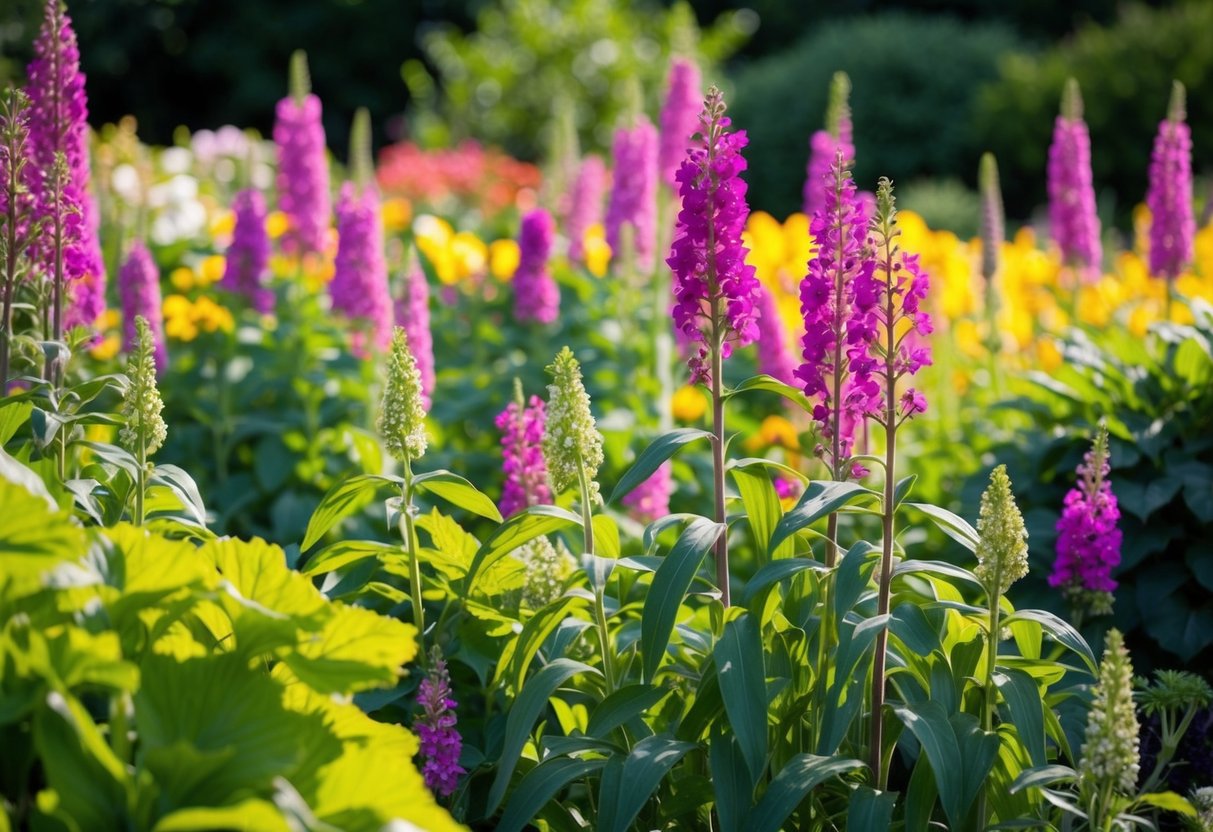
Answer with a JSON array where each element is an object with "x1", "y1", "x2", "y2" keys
[{"x1": 640, "y1": 518, "x2": 724, "y2": 682}]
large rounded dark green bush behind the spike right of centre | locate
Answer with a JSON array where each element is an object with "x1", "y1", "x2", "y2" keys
[{"x1": 730, "y1": 13, "x2": 1023, "y2": 216}]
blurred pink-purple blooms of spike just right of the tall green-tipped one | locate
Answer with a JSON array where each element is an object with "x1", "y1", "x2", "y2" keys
[{"x1": 329, "y1": 182, "x2": 392, "y2": 353}]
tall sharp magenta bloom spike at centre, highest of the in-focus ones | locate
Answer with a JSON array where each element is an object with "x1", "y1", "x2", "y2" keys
[{"x1": 666, "y1": 87, "x2": 761, "y2": 382}]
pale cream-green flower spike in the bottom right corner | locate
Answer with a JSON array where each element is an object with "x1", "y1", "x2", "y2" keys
[{"x1": 1078, "y1": 628, "x2": 1141, "y2": 800}]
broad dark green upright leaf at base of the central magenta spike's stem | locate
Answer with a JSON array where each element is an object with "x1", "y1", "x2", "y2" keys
[{"x1": 712, "y1": 612, "x2": 768, "y2": 782}]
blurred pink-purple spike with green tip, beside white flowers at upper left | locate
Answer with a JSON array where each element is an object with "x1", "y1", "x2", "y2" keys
[{"x1": 274, "y1": 52, "x2": 330, "y2": 255}]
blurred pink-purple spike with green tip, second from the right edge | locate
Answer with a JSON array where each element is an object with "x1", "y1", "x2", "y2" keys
[{"x1": 1048, "y1": 78, "x2": 1103, "y2": 281}]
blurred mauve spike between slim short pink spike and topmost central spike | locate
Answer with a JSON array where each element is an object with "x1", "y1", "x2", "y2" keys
[{"x1": 605, "y1": 115, "x2": 657, "y2": 272}]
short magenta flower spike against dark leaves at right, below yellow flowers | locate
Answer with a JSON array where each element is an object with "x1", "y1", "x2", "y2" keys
[{"x1": 1049, "y1": 426, "x2": 1122, "y2": 615}]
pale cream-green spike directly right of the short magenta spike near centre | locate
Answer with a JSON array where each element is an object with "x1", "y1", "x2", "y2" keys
[{"x1": 543, "y1": 347, "x2": 603, "y2": 500}]
